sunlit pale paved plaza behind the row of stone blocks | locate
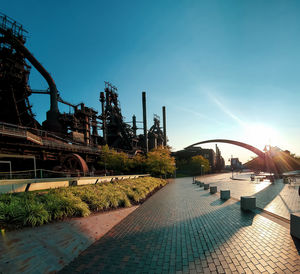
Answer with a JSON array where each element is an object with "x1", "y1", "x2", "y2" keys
[{"x1": 198, "y1": 173, "x2": 300, "y2": 220}]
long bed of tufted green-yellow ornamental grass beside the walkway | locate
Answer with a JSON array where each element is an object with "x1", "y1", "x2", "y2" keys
[{"x1": 0, "y1": 177, "x2": 167, "y2": 229}]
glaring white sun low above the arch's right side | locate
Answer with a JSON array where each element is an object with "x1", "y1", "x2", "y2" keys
[{"x1": 244, "y1": 124, "x2": 278, "y2": 150}]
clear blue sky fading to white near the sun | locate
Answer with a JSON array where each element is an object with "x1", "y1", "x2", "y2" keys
[{"x1": 1, "y1": 0, "x2": 300, "y2": 162}]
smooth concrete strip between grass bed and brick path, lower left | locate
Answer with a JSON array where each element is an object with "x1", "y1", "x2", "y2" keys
[{"x1": 0, "y1": 206, "x2": 138, "y2": 274}]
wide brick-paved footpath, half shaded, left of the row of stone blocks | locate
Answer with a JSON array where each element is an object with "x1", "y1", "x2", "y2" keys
[{"x1": 61, "y1": 178, "x2": 300, "y2": 273}]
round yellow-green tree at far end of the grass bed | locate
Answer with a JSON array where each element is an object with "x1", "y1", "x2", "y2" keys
[{"x1": 146, "y1": 147, "x2": 175, "y2": 176}]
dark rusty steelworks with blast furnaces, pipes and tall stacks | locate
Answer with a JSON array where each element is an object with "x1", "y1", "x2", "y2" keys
[{"x1": 0, "y1": 14, "x2": 167, "y2": 175}]
